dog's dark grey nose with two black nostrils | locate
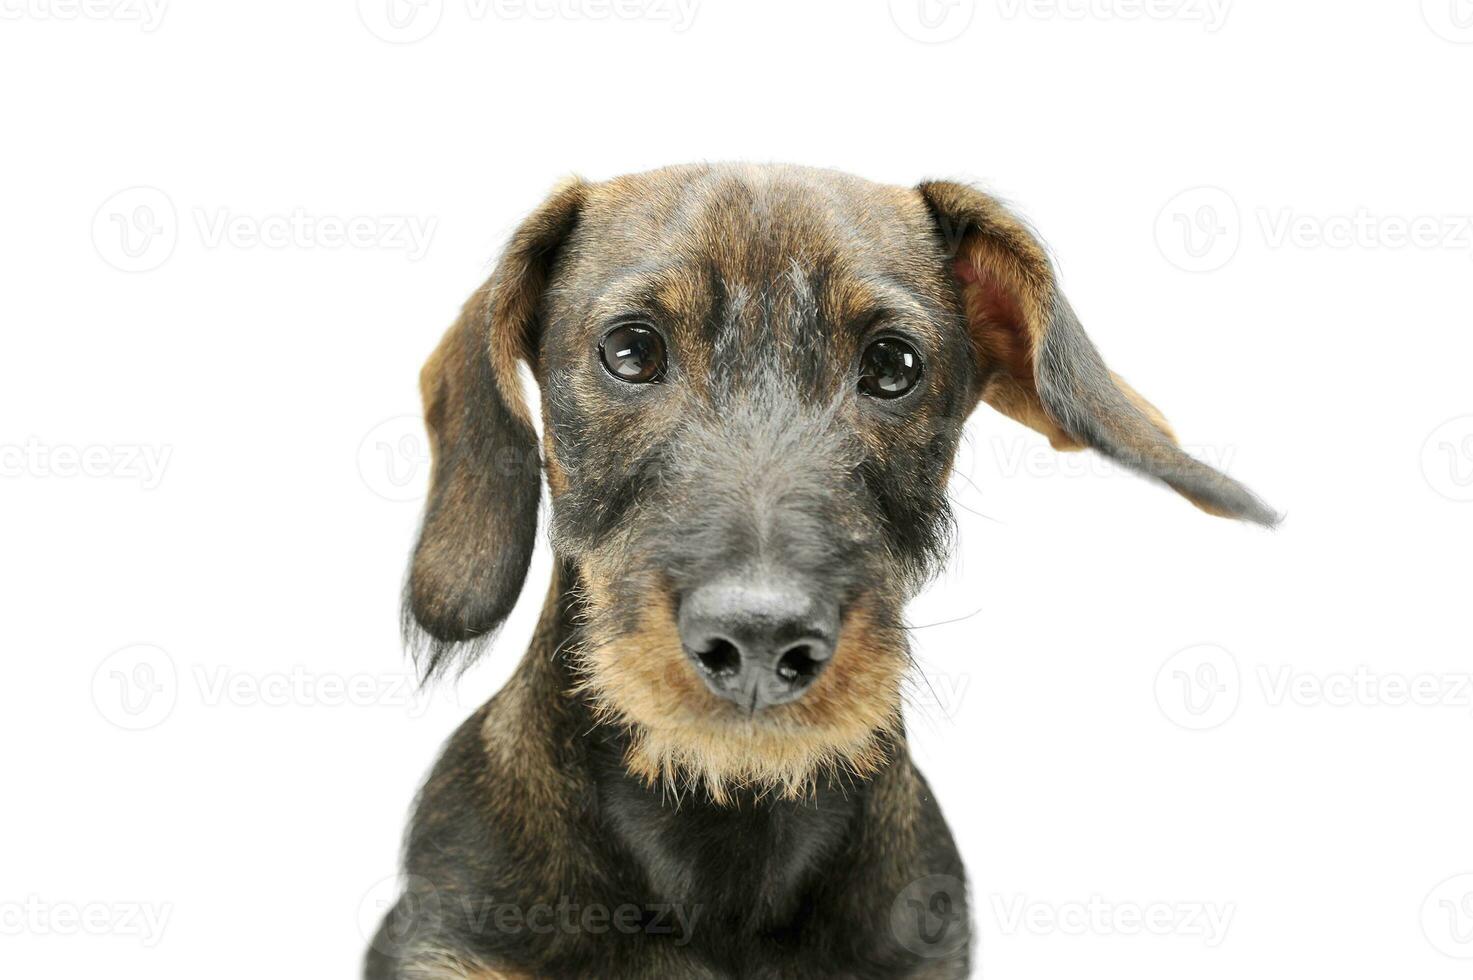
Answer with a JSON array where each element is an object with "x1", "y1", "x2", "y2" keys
[{"x1": 679, "y1": 575, "x2": 838, "y2": 712}]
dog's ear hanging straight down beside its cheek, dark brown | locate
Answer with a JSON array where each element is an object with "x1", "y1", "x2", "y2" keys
[{"x1": 404, "y1": 180, "x2": 586, "y2": 676}]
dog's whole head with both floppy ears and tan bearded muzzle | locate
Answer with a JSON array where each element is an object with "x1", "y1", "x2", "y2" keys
[{"x1": 407, "y1": 167, "x2": 1274, "y2": 797}]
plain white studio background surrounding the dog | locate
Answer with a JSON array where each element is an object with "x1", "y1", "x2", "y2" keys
[{"x1": 0, "y1": 0, "x2": 1473, "y2": 980}]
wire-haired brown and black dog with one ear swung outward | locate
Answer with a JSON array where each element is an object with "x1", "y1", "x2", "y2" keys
[{"x1": 367, "y1": 165, "x2": 1277, "y2": 980}]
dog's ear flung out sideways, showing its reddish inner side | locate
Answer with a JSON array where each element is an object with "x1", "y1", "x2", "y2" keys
[{"x1": 918, "y1": 181, "x2": 1279, "y2": 526}]
